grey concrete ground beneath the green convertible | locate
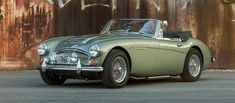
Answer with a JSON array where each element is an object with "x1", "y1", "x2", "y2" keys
[{"x1": 0, "y1": 71, "x2": 235, "y2": 103}]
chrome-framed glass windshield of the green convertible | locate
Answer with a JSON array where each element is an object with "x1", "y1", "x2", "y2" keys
[{"x1": 102, "y1": 20, "x2": 159, "y2": 37}]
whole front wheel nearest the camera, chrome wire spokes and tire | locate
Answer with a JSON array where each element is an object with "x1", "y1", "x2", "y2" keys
[{"x1": 102, "y1": 50, "x2": 130, "y2": 88}]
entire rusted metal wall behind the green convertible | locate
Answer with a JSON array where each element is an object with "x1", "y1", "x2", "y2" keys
[{"x1": 0, "y1": 0, "x2": 235, "y2": 69}]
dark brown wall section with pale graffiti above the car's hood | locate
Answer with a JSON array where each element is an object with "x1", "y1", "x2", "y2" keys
[{"x1": 54, "y1": 0, "x2": 112, "y2": 35}]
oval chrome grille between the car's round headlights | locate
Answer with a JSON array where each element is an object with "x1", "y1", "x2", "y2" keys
[{"x1": 52, "y1": 50, "x2": 89, "y2": 64}]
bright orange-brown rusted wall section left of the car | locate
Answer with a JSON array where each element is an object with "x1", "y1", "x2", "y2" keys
[{"x1": 0, "y1": 0, "x2": 54, "y2": 69}]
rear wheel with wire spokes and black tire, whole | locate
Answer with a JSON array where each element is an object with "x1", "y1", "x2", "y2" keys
[{"x1": 180, "y1": 48, "x2": 203, "y2": 82}]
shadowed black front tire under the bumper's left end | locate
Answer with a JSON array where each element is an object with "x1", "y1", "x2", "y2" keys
[{"x1": 40, "y1": 70, "x2": 66, "y2": 85}]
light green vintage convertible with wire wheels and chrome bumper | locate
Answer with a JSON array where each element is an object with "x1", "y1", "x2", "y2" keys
[{"x1": 37, "y1": 19, "x2": 215, "y2": 88}]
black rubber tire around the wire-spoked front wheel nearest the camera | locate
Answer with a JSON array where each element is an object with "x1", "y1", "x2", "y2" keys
[{"x1": 102, "y1": 49, "x2": 130, "y2": 88}]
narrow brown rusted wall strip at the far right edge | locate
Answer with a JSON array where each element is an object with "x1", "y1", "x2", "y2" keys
[{"x1": 218, "y1": 0, "x2": 235, "y2": 68}]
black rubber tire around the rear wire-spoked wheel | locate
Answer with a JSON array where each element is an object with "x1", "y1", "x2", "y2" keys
[{"x1": 180, "y1": 48, "x2": 203, "y2": 82}]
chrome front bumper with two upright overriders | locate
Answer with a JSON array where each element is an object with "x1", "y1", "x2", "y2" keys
[{"x1": 38, "y1": 60, "x2": 103, "y2": 74}]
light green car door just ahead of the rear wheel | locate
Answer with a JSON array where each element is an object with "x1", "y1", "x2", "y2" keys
[{"x1": 155, "y1": 38, "x2": 186, "y2": 75}]
